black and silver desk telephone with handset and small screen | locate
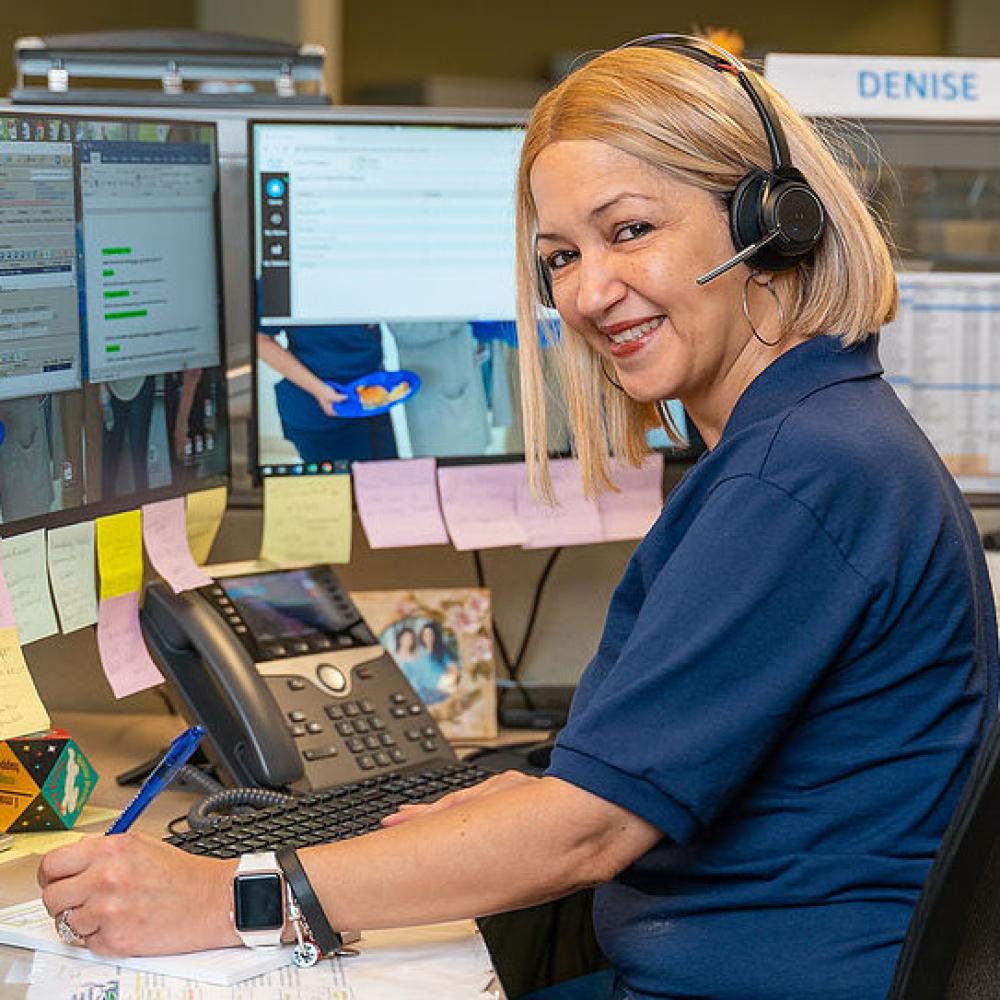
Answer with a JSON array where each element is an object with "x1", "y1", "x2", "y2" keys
[{"x1": 141, "y1": 566, "x2": 456, "y2": 792}]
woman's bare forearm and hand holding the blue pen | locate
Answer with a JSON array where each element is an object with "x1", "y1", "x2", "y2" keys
[{"x1": 39, "y1": 778, "x2": 661, "y2": 954}]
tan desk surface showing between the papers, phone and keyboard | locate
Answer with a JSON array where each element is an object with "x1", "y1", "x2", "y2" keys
[{"x1": 0, "y1": 712, "x2": 508, "y2": 1000}]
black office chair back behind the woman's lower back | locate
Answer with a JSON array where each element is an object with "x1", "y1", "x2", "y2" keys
[{"x1": 888, "y1": 719, "x2": 1000, "y2": 1000}]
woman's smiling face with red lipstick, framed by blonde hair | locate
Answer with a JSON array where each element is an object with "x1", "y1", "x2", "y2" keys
[{"x1": 531, "y1": 139, "x2": 793, "y2": 445}]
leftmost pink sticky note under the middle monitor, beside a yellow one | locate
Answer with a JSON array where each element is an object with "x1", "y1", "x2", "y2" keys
[{"x1": 351, "y1": 458, "x2": 448, "y2": 549}]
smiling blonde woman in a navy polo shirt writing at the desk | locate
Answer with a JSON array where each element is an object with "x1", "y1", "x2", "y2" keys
[{"x1": 41, "y1": 35, "x2": 997, "y2": 1000}]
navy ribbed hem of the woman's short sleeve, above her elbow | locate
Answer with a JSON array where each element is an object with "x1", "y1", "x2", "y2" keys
[{"x1": 545, "y1": 743, "x2": 701, "y2": 844}]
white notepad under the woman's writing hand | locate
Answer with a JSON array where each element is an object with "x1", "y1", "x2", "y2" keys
[{"x1": 0, "y1": 899, "x2": 292, "y2": 986}]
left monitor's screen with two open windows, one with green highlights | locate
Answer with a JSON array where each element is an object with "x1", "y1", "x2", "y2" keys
[{"x1": 0, "y1": 109, "x2": 229, "y2": 534}]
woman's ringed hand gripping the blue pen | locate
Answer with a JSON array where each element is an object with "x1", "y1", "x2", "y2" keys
[{"x1": 38, "y1": 833, "x2": 240, "y2": 955}]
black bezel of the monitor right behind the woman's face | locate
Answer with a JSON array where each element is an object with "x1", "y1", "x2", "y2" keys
[{"x1": 246, "y1": 107, "x2": 705, "y2": 487}]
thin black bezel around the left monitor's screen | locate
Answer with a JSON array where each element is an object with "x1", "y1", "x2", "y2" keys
[{"x1": 0, "y1": 105, "x2": 233, "y2": 538}]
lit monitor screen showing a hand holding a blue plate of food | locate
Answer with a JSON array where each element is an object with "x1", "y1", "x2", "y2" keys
[{"x1": 248, "y1": 114, "x2": 693, "y2": 477}]
